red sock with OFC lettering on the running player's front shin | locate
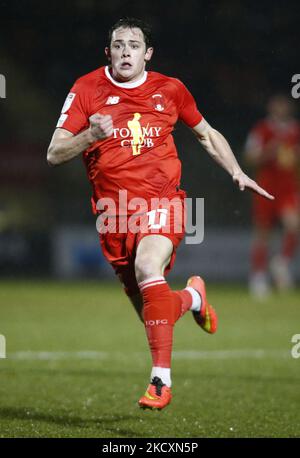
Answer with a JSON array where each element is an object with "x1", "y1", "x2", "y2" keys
[{"x1": 139, "y1": 277, "x2": 178, "y2": 368}]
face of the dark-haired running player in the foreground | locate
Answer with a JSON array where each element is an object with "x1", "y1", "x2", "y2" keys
[{"x1": 105, "y1": 27, "x2": 153, "y2": 82}]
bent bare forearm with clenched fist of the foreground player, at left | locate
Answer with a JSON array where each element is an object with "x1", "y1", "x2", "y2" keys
[{"x1": 47, "y1": 113, "x2": 113, "y2": 166}]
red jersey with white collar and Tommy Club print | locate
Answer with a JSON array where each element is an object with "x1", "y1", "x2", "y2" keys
[{"x1": 57, "y1": 67, "x2": 202, "y2": 215}]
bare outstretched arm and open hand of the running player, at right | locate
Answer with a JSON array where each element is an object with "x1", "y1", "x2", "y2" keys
[{"x1": 192, "y1": 118, "x2": 274, "y2": 200}]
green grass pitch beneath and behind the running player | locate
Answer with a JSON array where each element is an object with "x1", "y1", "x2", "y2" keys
[{"x1": 0, "y1": 281, "x2": 300, "y2": 438}]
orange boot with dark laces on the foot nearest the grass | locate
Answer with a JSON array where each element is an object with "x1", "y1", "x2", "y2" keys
[{"x1": 139, "y1": 377, "x2": 172, "y2": 410}]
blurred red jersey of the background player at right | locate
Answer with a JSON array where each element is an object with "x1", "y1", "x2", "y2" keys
[{"x1": 246, "y1": 118, "x2": 300, "y2": 192}]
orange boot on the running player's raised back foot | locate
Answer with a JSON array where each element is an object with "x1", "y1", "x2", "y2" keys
[{"x1": 186, "y1": 276, "x2": 218, "y2": 334}]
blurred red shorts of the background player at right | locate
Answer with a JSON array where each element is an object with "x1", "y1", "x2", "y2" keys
[{"x1": 253, "y1": 192, "x2": 299, "y2": 229}]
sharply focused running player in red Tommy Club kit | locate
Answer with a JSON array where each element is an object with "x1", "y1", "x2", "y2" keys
[{"x1": 47, "y1": 18, "x2": 272, "y2": 409}]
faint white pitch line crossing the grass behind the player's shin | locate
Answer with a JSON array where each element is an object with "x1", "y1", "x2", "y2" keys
[{"x1": 7, "y1": 349, "x2": 291, "y2": 361}]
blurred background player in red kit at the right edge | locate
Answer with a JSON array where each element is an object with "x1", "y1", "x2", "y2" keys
[{"x1": 245, "y1": 95, "x2": 300, "y2": 297}]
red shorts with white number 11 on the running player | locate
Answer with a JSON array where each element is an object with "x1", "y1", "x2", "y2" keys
[{"x1": 100, "y1": 191, "x2": 186, "y2": 296}]
